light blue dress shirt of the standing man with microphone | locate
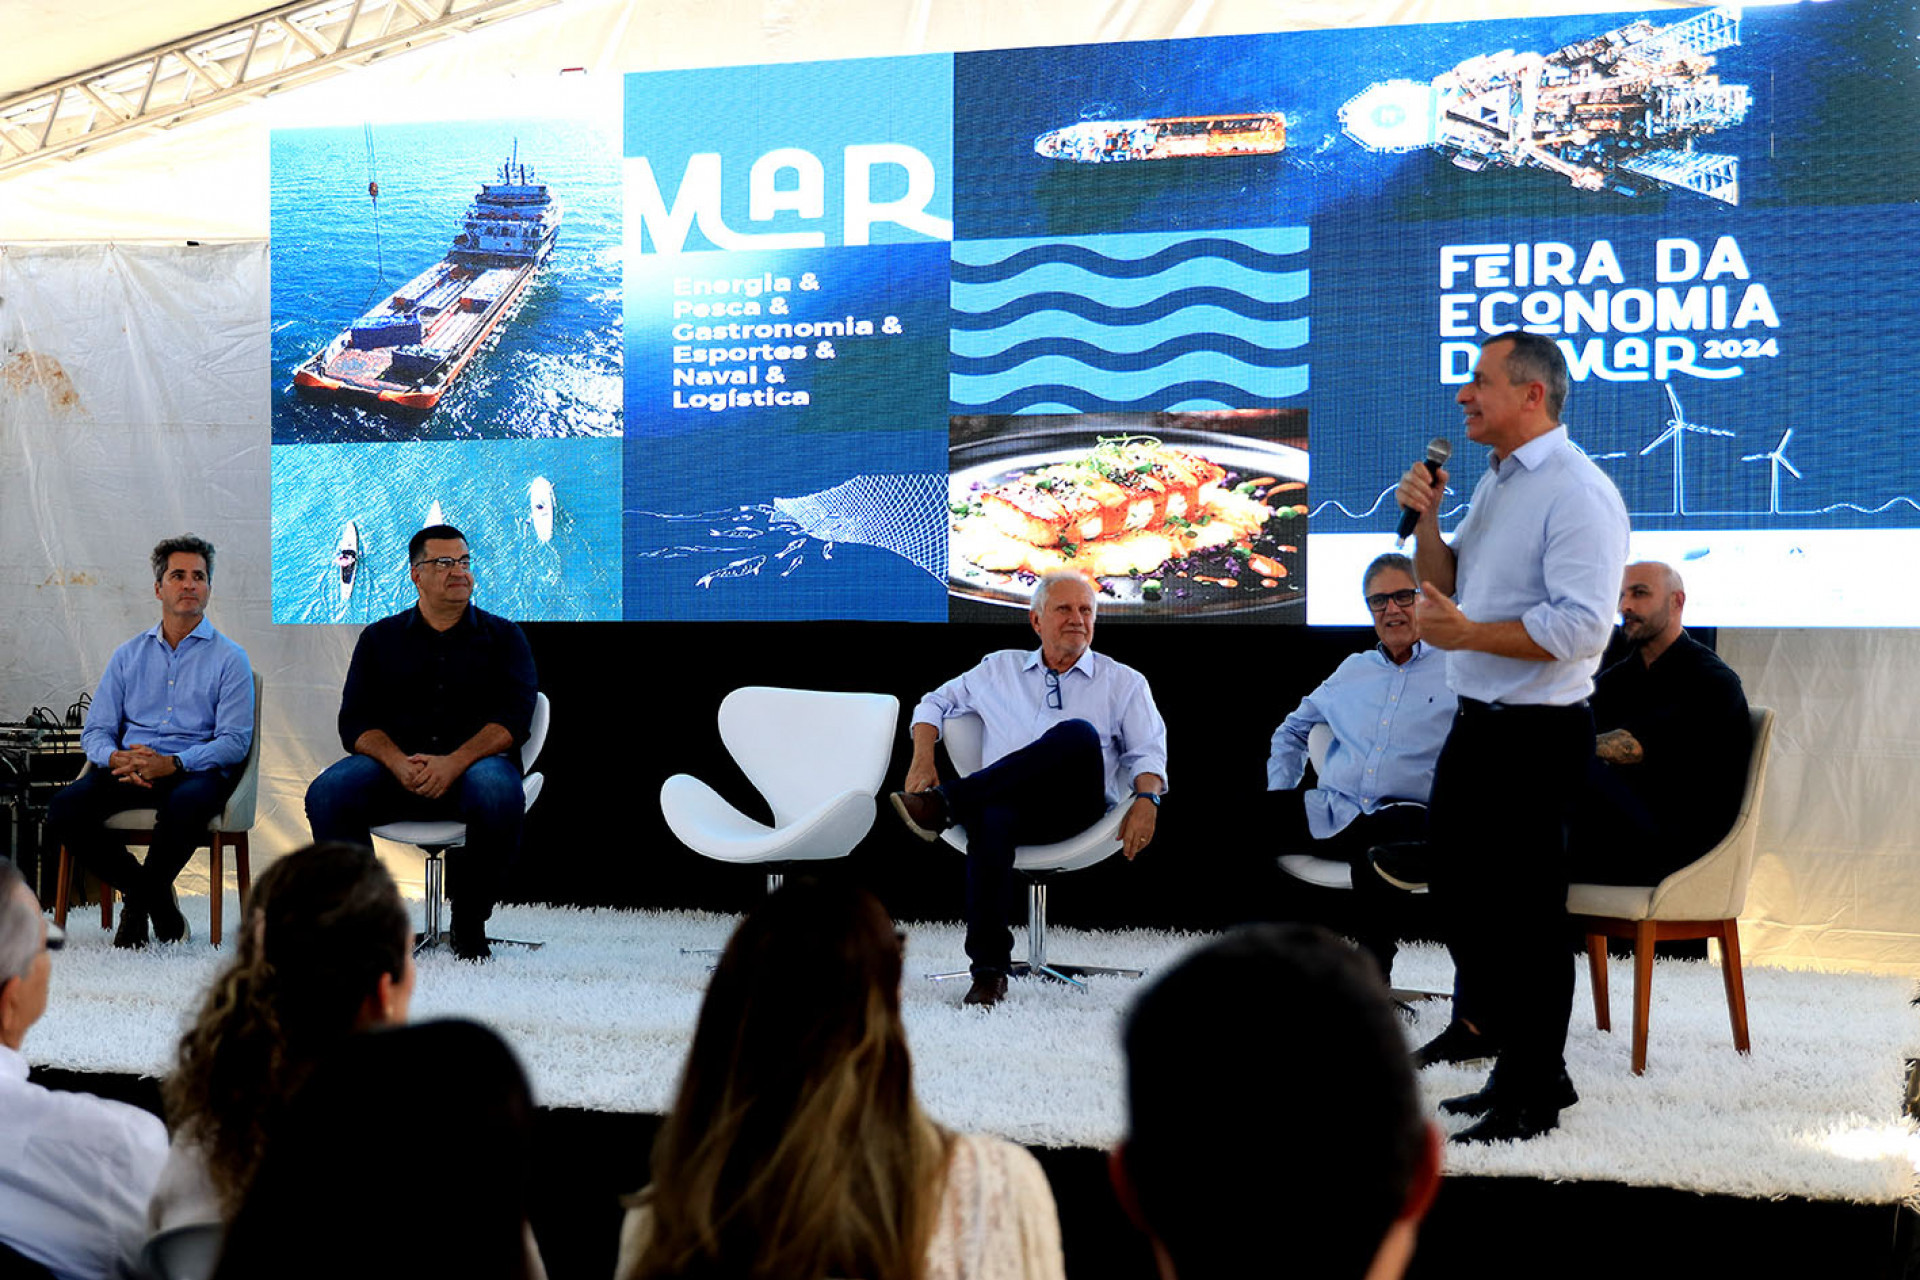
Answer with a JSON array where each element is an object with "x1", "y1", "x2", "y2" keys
[{"x1": 1448, "y1": 426, "x2": 1628, "y2": 706}]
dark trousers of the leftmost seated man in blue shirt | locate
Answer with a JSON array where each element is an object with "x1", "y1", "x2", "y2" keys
[{"x1": 46, "y1": 766, "x2": 240, "y2": 913}]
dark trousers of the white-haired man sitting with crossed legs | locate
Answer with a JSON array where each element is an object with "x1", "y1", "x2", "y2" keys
[{"x1": 941, "y1": 720, "x2": 1106, "y2": 977}]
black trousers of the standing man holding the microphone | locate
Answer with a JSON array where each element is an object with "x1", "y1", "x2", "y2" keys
[{"x1": 1427, "y1": 699, "x2": 1594, "y2": 1103}]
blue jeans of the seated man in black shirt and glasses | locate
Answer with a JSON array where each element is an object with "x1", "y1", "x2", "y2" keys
[{"x1": 307, "y1": 754, "x2": 526, "y2": 923}]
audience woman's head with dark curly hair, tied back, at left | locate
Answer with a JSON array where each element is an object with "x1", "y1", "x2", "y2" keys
[{"x1": 165, "y1": 842, "x2": 413, "y2": 1213}]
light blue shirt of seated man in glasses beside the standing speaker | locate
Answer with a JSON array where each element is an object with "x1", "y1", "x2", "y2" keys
[{"x1": 1267, "y1": 641, "x2": 1455, "y2": 841}]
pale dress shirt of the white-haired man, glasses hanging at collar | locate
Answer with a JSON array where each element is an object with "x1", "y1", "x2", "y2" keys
[{"x1": 908, "y1": 649, "x2": 1167, "y2": 806}]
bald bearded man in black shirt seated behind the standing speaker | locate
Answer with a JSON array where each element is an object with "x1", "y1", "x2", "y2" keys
[{"x1": 1569, "y1": 560, "x2": 1753, "y2": 885}]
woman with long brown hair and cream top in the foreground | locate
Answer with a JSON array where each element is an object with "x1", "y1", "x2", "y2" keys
[{"x1": 616, "y1": 885, "x2": 1066, "y2": 1280}]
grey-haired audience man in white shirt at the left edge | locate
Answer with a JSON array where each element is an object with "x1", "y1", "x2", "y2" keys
[{"x1": 0, "y1": 862, "x2": 167, "y2": 1280}]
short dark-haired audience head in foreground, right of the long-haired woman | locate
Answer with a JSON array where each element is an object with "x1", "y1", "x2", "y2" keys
[{"x1": 1114, "y1": 925, "x2": 1440, "y2": 1280}]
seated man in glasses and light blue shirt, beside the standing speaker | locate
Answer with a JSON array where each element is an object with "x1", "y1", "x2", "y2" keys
[{"x1": 1267, "y1": 553, "x2": 1453, "y2": 979}]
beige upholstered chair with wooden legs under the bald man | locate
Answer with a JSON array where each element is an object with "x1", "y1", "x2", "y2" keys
[{"x1": 1567, "y1": 706, "x2": 1774, "y2": 1075}]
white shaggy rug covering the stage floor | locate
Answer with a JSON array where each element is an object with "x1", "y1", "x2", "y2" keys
[{"x1": 25, "y1": 896, "x2": 1920, "y2": 1203}]
